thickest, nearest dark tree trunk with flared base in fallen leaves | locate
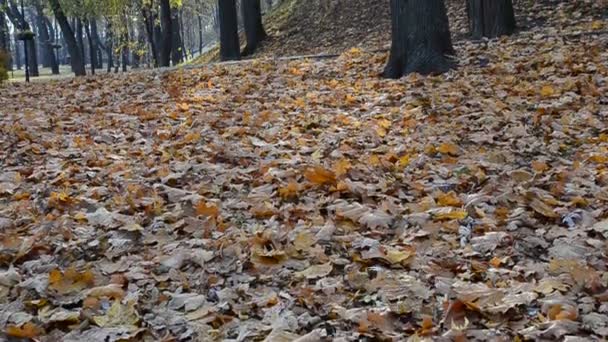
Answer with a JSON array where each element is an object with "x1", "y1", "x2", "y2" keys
[{"x1": 383, "y1": 0, "x2": 456, "y2": 78}]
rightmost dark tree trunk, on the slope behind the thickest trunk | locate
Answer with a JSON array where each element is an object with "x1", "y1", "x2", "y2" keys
[{"x1": 467, "y1": 0, "x2": 516, "y2": 39}]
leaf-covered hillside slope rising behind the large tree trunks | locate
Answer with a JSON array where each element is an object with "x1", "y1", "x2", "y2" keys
[{"x1": 222, "y1": 0, "x2": 608, "y2": 57}]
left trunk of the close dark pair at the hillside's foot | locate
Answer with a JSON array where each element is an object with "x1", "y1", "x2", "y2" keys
[{"x1": 218, "y1": 0, "x2": 241, "y2": 61}]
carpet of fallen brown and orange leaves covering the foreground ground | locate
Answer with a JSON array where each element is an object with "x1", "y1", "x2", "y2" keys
[{"x1": 0, "y1": 3, "x2": 608, "y2": 341}]
